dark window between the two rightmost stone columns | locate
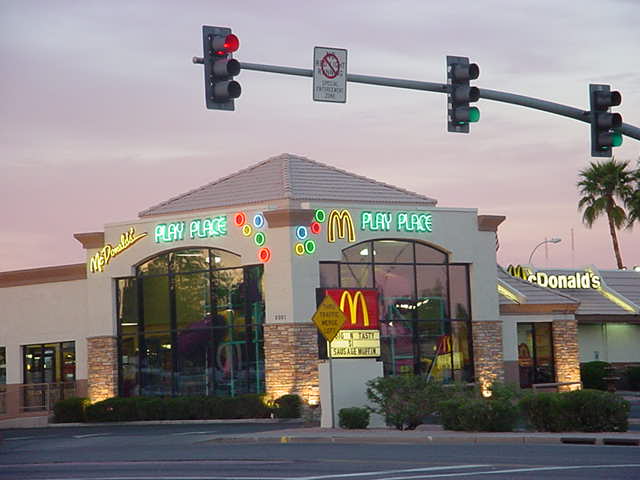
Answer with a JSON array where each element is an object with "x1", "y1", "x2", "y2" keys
[{"x1": 518, "y1": 322, "x2": 555, "y2": 388}]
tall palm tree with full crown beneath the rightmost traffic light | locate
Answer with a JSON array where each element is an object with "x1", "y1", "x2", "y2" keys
[{"x1": 578, "y1": 158, "x2": 633, "y2": 269}]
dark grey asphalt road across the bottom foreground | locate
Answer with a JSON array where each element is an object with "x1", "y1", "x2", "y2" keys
[{"x1": 0, "y1": 424, "x2": 640, "y2": 480}]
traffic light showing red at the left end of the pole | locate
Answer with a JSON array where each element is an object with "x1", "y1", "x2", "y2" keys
[{"x1": 202, "y1": 25, "x2": 242, "y2": 110}]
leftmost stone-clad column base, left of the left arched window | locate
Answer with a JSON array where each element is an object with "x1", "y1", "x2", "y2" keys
[{"x1": 87, "y1": 336, "x2": 118, "y2": 402}]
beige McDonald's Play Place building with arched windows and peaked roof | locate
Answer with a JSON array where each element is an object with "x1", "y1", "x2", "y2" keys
[{"x1": 0, "y1": 154, "x2": 592, "y2": 419}]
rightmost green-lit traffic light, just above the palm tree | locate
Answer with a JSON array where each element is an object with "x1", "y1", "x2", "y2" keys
[{"x1": 589, "y1": 84, "x2": 622, "y2": 157}]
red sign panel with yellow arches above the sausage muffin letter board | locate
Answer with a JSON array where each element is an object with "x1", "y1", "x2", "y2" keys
[{"x1": 326, "y1": 288, "x2": 379, "y2": 330}]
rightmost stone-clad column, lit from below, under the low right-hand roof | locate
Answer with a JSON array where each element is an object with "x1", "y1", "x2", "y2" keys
[{"x1": 552, "y1": 320, "x2": 580, "y2": 391}]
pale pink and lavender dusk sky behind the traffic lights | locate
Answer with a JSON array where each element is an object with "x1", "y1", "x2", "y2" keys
[{"x1": 0, "y1": 0, "x2": 640, "y2": 271}]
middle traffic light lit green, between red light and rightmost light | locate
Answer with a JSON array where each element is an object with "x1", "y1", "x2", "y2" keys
[{"x1": 447, "y1": 56, "x2": 480, "y2": 133}]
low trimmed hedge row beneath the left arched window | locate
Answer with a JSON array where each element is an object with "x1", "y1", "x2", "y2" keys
[{"x1": 54, "y1": 394, "x2": 302, "y2": 423}]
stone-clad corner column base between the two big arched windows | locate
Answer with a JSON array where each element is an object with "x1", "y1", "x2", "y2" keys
[{"x1": 264, "y1": 323, "x2": 320, "y2": 403}]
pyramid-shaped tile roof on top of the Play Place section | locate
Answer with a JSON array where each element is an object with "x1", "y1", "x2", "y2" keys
[{"x1": 139, "y1": 153, "x2": 437, "y2": 217}]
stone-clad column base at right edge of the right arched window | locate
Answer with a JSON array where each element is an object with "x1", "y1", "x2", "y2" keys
[{"x1": 471, "y1": 321, "x2": 504, "y2": 392}]
